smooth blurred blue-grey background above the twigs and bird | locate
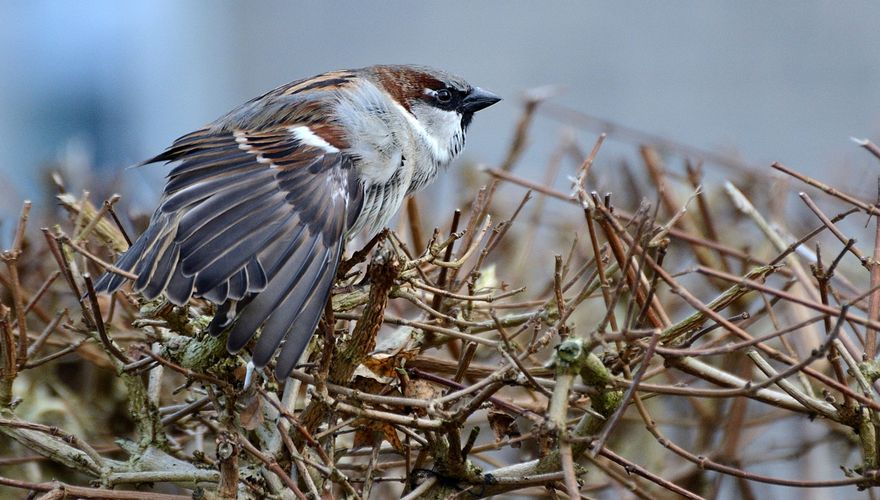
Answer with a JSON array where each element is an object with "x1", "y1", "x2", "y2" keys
[{"x1": 0, "y1": 0, "x2": 880, "y2": 219}]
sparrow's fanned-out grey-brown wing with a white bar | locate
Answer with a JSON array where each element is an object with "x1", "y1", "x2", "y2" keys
[{"x1": 96, "y1": 125, "x2": 363, "y2": 377}]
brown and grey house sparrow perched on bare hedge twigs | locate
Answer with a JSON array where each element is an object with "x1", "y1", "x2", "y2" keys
[{"x1": 96, "y1": 66, "x2": 500, "y2": 379}]
